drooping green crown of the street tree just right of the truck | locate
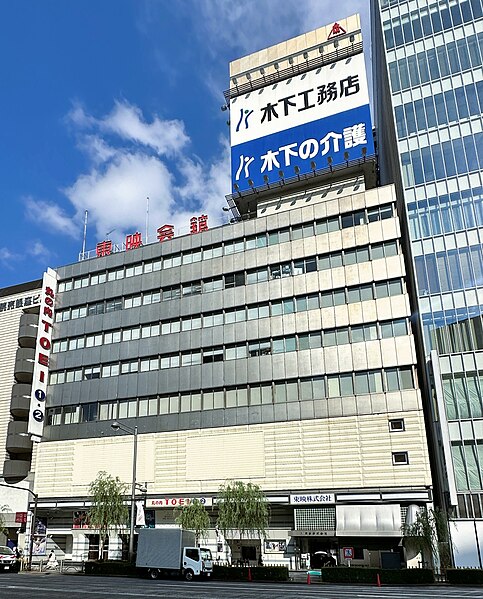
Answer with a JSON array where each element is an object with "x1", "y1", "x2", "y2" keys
[{"x1": 216, "y1": 480, "x2": 270, "y2": 538}]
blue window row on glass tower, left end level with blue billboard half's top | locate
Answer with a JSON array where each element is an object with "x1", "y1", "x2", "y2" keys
[{"x1": 394, "y1": 81, "x2": 483, "y2": 139}]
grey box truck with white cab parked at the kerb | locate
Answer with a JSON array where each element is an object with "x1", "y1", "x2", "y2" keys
[{"x1": 136, "y1": 528, "x2": 213, "y2": 580}]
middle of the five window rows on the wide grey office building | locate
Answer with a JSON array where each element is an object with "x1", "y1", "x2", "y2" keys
[{"x1": 52, "y1": 279, "x2": 403, "y2": 353}]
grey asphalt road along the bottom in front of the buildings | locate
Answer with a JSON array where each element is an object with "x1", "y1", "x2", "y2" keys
[{"x1": 0, "y1": 573, "x2": 482, "y2": 599}]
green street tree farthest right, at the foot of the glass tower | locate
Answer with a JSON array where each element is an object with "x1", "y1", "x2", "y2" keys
[{"x1": 401, "y1": 507, "x2": 451, "y2": 570}]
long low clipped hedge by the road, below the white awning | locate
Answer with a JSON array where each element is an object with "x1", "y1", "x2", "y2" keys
[{"x1": 322, "y1": 566, "x2": 434, "y2": 585}]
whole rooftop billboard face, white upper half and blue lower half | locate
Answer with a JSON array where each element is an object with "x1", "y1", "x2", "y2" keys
[{"x1": 230, "y1": 54, "x2": 374, "y2": 191}]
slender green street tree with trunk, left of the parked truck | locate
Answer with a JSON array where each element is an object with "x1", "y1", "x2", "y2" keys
[{"x1": 89, "y1": 472, "x2": 129, "y2": 560}]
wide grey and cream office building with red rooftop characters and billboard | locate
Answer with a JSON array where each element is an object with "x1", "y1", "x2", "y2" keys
[{"x1": 4, "y1": 16, "x2": 432, "y2": 567}]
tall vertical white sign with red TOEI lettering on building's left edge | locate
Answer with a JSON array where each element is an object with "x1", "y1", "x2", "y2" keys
[{"x1": 28, "y1": 268, "x2": 57, "y2": 443}]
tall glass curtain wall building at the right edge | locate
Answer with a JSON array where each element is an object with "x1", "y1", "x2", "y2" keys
[{"x1": 371, "y1": 0, "x2": 483, "y2": 567}]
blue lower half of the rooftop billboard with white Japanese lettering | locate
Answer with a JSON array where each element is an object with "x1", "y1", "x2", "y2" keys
[{"x1": 231, "y1": 104, "x2": 374, "y2": 191}]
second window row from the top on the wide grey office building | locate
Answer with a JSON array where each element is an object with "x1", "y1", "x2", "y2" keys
[{"x1": 55, "y1": 241, "x2": 399, "y2": 322}]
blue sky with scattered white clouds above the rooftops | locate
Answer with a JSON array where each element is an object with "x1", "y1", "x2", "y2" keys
[{"x1": 0, "y1": 0, "x2": 369, "y2": 287}]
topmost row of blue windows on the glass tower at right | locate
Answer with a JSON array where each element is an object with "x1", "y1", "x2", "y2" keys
[{"x1": 383, "y1": 0, "x2": 482, "y2": 50}]
